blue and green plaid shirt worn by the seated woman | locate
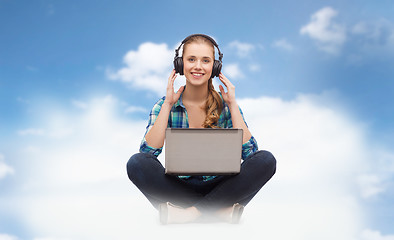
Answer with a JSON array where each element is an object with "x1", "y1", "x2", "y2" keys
[{"x1": 140, "y1": 95, "x2": 258, "y2": 181}]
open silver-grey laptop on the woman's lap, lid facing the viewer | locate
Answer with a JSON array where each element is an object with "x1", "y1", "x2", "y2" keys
[{"x1": 165, "y1": 128, "x2": 243, "y2": 175}]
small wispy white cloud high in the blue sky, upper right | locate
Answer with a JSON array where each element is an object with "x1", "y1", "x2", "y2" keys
[{"x1": 300, "y1": 7, "x2": 346, "y2": 54}]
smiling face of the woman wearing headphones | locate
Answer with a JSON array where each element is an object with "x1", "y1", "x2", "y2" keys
[{"x1": 182, "y1": 42, "x2": 215, "y2": 85}]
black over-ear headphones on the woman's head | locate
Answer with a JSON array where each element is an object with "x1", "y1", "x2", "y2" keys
[{"x1": 174, "y1": 34, "x2": 223, "y2": 78}]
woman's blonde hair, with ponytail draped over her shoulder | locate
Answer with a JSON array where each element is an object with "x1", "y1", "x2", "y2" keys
[{"x1": 182, "y1": 36, "x2": 223, "y2": 128}]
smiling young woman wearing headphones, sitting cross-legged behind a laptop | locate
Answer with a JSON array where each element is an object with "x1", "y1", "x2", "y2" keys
[{"x1": 127, "y1": 34, "x2": 276, "y2": 223}]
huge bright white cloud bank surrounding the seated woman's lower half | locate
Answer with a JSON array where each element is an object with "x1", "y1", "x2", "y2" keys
[{"x1": 2, "y1": 91, "x2": 394, "y2": 240}]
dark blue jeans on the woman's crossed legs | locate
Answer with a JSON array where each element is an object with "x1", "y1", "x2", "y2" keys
[{"x1": 127, "y1": 151, "x2": 276, "y2": 212}]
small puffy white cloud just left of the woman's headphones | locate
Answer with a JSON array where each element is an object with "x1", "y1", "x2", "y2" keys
[{"x1": 107, "y1": 42, "x2": 174, "y2": 96}]
